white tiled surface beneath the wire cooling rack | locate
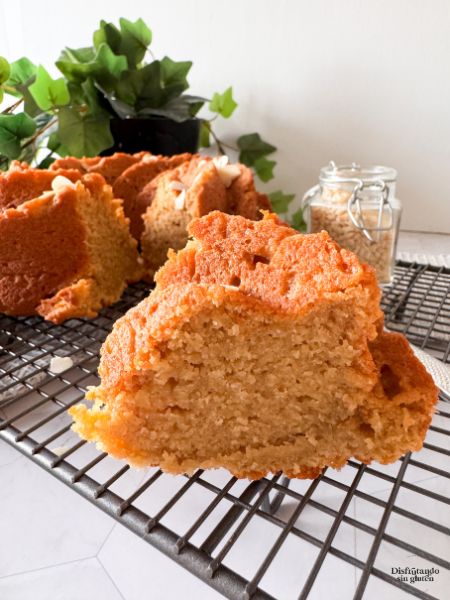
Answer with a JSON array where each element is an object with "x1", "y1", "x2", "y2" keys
[{"x1": 0, "y1": 233, "x2": 450, "y2": 600}]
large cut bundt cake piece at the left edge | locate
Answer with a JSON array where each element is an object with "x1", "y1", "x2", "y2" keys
[{"x1": 0, "y1": 170, "x2": 142, "y2": 323}]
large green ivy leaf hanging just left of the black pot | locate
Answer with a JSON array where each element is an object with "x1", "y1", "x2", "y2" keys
[{"x1": 58, "y1": 107, "x2": 114, "y2": 156}]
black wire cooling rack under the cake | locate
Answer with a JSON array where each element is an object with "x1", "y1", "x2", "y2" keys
[{"x1": 0, "y1": 262, "x2": 450, "y2": 599}]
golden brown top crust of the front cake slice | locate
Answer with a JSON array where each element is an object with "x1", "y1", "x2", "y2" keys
[{"x1": 155, "y1": 212, "x2": 382, "y2": 318}]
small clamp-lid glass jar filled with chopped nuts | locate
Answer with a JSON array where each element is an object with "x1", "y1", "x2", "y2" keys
[{"x1": 303, "y1": 162, "x2": 401, "y2": 283}]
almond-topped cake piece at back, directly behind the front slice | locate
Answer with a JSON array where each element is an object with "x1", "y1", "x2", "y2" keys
[{"x1": 138, "y1": 156, "x2": 270, "y2": 277}]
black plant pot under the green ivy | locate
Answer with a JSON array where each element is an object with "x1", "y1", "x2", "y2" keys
[{"x1": 102, "y1": 117, "x2": 200, "y2": 156}]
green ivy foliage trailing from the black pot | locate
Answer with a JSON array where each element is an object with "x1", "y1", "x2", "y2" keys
[{"x1": 0, "y1": 18, "x2": 304, "y2": 230}]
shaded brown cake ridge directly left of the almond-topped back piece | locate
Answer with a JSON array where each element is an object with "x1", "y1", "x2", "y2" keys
[{"x1": 113, "y1": 153, "x2": 191, "y2": 240}]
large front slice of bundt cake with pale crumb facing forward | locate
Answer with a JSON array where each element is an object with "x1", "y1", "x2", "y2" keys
[{"x1": 71, "y1": 212, "x2": 437, "y2": 478}]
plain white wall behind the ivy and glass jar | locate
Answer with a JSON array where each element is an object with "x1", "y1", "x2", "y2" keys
[{"x1": 0, "y1": 0, "x2": 450, "y2": 232}]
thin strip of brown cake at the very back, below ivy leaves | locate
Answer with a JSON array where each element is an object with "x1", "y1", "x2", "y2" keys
[{"x1": 50, "y1": 152, "x2": 150, "y2": 185}]
